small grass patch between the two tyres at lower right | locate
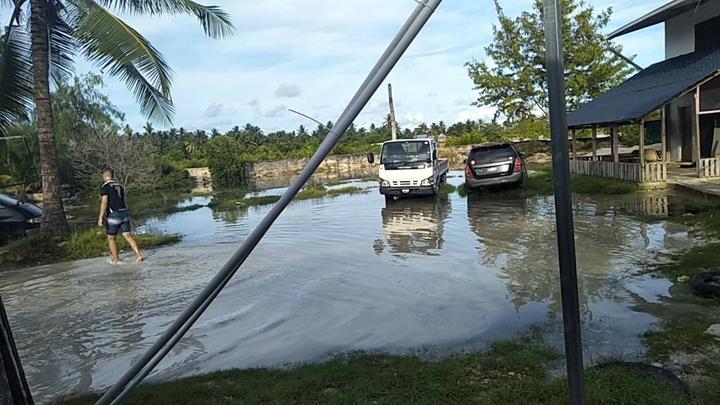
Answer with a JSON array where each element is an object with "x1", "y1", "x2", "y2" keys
[{"x1": 644, "y1": 321, "x2": 718, "y2": 361}]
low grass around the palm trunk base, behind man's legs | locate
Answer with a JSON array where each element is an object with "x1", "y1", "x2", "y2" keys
[{"x1": 0, "y1": 228, "x2": 181, "y2": 266}]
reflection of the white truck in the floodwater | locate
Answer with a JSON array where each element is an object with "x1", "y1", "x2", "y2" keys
[{"x1": 373, "y1": 198, "x2": 451, "y2": 255}]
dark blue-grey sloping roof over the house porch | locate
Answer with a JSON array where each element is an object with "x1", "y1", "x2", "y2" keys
[{"x1": 568, "y1": 49, "x2": 720, "y2": 128}]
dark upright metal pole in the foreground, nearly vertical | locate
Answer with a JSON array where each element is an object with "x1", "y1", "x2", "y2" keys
[{"x1": 544, "y1": 0, "x2": 585, "y2": 405}]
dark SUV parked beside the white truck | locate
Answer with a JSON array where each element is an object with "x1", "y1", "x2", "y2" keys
[{"x1": 465, "y1": 142, "x2": 527, "y2": 189}]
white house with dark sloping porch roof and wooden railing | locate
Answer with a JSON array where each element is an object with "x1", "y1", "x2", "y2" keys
[{"x1": 568, "y1": 0, "x2": 720, "y2": 182}]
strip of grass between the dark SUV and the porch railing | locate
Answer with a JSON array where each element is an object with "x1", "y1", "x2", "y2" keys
[{"x1": 521, "y1": 170, "x2": 640, "y2": 197}]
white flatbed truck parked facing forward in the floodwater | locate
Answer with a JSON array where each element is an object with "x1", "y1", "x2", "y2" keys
[{"x1": 368, "y1": 139, "x2": 450, "y2": 200}]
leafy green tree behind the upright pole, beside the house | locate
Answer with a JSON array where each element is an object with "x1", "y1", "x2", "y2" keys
[{"x1": 466, "y1": 0, "x2": 633, "y2": 122}]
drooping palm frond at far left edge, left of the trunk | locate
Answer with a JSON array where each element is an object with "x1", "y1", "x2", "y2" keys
[{"x1": 0, "y1": 26, "x2": 33, "y2": 134}]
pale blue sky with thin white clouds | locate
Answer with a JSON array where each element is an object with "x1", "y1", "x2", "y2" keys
[{"x1": 2, "y1": 0, "x2": 666, "y2": 131}]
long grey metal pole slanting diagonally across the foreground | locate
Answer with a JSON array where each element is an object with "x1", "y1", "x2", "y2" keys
[{"x1": 97, "y1": 0, "x2": 442, "y2": 404}]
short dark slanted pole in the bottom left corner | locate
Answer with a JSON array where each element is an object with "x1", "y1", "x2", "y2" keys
[{"x1": 0, "y1": 297, "x2": 33, "y2": 405}]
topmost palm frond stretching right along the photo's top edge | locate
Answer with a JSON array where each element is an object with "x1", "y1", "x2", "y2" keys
[{"x1": 97, "y1": 0, "x2": 235, "y2": 38}]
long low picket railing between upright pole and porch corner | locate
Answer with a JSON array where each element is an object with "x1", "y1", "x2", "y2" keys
[{"x1": 570, "y1": 160, "x2": 667, "y2": 183}]
